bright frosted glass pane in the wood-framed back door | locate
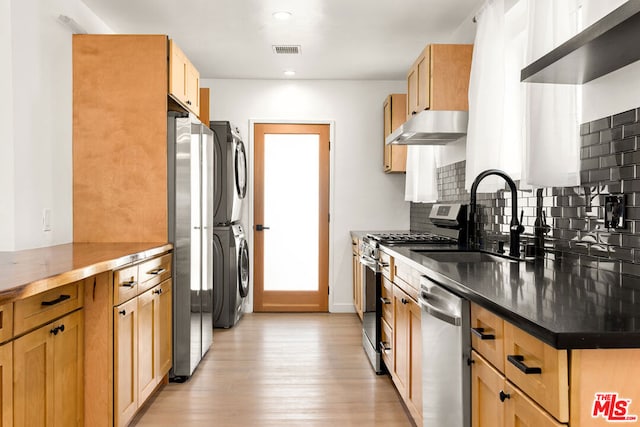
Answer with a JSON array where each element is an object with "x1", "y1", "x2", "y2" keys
[{"x1": 263, "y1": 134, "x2": 320, "y2": 291}]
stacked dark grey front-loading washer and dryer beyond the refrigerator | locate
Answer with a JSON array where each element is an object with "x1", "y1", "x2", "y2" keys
[{"x1": 210, "y1": 121, "x2": 249, "y2": 328}]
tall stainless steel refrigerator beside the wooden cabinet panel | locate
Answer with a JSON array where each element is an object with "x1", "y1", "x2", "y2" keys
[{"x1": 167, "y1": 112, "x2": 214, "y2": 381}]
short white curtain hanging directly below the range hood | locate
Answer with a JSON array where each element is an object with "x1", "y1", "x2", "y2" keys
[{"x1": 404, "y1": 145, "x2": 440, "y2": 203}]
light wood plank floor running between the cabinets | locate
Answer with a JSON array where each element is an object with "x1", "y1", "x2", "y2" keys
[{"x1": 132, "y1": 313, "x2": 413, "y2": 427}]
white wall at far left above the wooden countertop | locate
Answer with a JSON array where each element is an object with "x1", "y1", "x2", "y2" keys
[{"x1": 0, "y1": 0, "x2": 111, "y2": 250}]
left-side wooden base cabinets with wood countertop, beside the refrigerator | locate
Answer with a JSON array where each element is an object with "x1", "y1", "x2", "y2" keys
[{"x1": 0, "y1": 243, "x2": 173, "y2": 426}]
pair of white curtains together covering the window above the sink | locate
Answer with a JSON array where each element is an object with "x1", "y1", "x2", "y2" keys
[{"x1": 465, "y1": 0, "x2": 580, "y2": 191}]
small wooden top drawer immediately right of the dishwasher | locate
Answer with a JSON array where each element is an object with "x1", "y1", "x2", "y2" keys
[{"x1": 471, "y1": 303, "x2": 504, "y2": 372}]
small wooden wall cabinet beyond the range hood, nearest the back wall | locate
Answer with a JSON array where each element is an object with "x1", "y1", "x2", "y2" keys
[{"x1": 382, "y1": 93, "x2": 407, "y2": 173}]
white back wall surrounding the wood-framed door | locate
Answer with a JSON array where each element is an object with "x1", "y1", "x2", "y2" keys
[{"x1": 206, "y1": 79, "x2": 409, "y2": 312}]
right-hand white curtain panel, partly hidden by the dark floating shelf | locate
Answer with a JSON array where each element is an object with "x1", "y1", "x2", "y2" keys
[{"x1": 522, "y1": 0, "x2": 580, "y2": 187}]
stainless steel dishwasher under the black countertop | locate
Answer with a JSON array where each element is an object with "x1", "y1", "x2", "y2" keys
[{"x1": 419, "y1": 276, "x2": 471, "y2": 427}]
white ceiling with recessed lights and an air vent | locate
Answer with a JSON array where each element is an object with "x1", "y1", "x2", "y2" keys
[{"x1": 83, "y1": 0, "x2": 482, "y2": 80}]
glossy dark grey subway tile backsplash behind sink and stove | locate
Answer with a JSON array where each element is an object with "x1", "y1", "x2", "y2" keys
[{"x1": 410, "y1": 108, "x2": 640, "y2": 276}]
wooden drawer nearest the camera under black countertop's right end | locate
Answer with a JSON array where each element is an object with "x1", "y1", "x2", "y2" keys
[{"x1": 504, "y1": 322, "x2": 569, "y2": 422}]
